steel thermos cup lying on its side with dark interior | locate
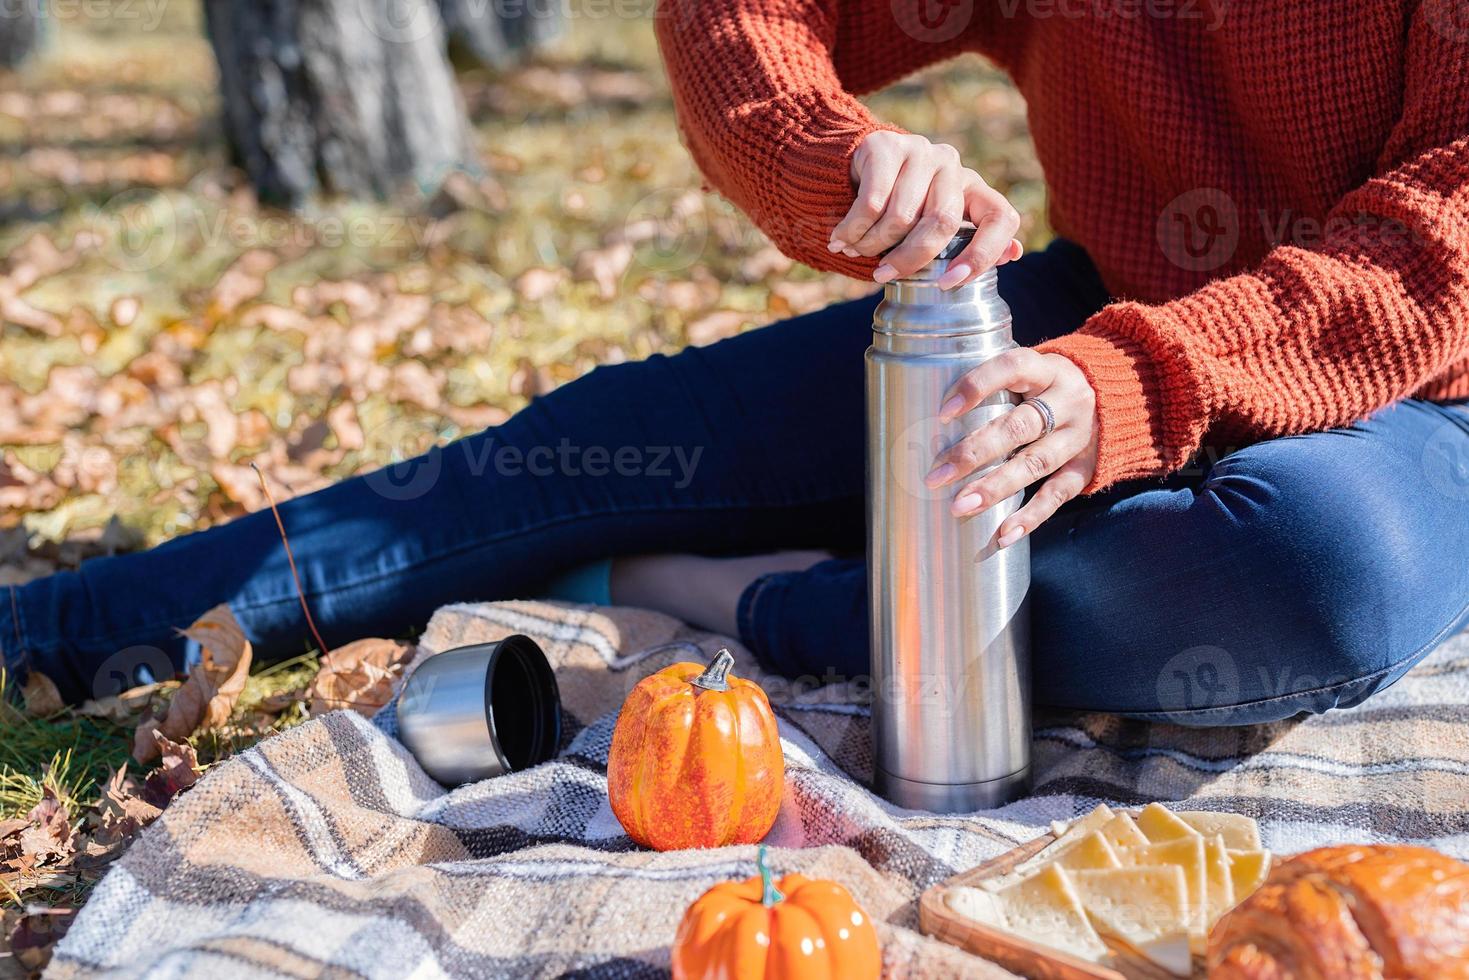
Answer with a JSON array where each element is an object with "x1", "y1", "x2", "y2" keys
[{"x1": 398, "y1": 635, "x2": 561, "y2": 786}]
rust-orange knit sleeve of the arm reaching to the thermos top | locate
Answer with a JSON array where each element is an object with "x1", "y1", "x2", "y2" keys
[{"x1": 657, "y1": 0, "x2": 898, "y2": 278}]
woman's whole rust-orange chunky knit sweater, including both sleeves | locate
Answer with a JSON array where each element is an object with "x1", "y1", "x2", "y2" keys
[{"x1": 658, "y1": 0, "x2": 1469, "y2": 491}]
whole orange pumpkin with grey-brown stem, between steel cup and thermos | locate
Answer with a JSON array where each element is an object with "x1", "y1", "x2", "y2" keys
[{"x1": 607, "y1": 649, "x2": 786, "y2": 851}]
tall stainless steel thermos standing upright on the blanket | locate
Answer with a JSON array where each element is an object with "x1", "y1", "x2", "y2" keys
[{"x1": 867, "y1": 229, "x2": 1030, "y2": 813}]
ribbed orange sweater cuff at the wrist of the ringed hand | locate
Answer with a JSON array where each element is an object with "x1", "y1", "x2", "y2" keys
[{"x1": 1036, "y1": 332, "x2": 1168, "y2": 494}]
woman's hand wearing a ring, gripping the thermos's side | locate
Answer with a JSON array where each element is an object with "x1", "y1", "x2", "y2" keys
[{"x1": 924, "y1": 347, "x2": 1097, "y2": 548}]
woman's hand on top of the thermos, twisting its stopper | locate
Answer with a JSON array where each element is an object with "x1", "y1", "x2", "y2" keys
[{"x1": 827, "y1": 131, "x2": 1021, "y2": 289}]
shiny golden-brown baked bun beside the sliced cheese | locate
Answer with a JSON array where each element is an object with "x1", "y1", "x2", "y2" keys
[{"x1": 1209, "y1": 845, "x2": 1469, "y2": 980}]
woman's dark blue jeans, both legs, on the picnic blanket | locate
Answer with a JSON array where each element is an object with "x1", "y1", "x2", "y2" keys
[{"x1": 0, "y1": 242, "x2": 1469, "y2": 724}]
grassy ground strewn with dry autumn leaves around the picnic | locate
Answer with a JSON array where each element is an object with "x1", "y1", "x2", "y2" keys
[{"x1": 0, "y1": 0, "x2": 1049, "y2": 973}]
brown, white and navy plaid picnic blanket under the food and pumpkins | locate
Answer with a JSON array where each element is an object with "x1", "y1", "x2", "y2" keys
[{"x1": 47, "y1": 602, "x2": 1469, "y2": 977}]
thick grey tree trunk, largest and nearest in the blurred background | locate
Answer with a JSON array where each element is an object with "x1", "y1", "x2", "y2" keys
[{"x1": 204, "y1": 0, "x2": 473, "y2": 207}]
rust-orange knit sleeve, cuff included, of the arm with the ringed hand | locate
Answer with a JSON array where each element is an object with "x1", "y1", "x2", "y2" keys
[{"x1": 1039, "y1": 4, "x2": 1469, "y2": 492}]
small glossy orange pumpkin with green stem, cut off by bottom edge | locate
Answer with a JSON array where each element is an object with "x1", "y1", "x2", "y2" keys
[{"x1": 673, "y1": 845, "x2": 883, "y2": 980}]
